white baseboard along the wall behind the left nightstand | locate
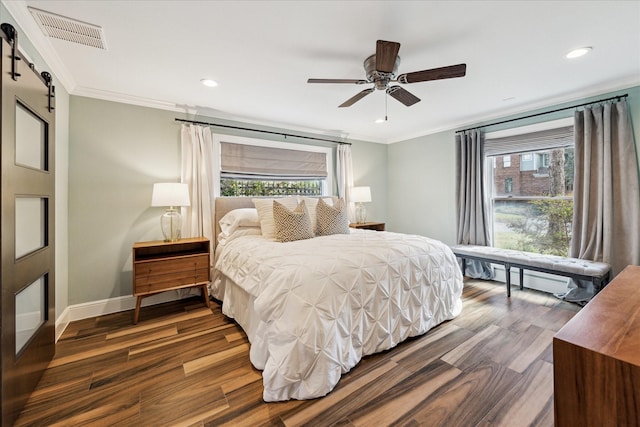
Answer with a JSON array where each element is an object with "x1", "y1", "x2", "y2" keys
[{"x1": 56, "y1": 289, "x2": 200, "y2": 342}]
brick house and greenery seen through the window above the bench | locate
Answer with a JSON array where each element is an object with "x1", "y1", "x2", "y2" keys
[{"x1": 487, "y1": 130, "x2": 574, "y2": 256}]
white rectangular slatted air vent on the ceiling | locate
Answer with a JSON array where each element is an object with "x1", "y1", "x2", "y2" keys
[{"x1": 29, "y1": 6, "x2": 107, "y2": 49}]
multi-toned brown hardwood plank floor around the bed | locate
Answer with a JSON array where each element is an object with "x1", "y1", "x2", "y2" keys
[{"x1": 17, "y1": 280, "x2": 579, "y2": 426}]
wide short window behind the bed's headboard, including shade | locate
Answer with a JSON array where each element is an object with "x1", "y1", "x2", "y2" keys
[{"x1": 214, "y1": 135, "x2": 332, "y2": 196}]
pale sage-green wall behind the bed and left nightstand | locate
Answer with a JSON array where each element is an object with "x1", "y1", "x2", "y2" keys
[{"x1": 69, "y1": 96, "x2": 387, "y2": 304}]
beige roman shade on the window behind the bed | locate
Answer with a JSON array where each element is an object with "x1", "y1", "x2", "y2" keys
[{"x1": 220, "y1": 142, "x2": 327, "y2": 179}]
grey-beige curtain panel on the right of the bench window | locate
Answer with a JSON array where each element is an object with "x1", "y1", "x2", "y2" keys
[{"x1": 570, "y1": 100, "x2": 640, "y2": 288}]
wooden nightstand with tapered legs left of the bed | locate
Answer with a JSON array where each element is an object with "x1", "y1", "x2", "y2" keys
[{"x1": 133, "y1": 237, "x2": 211, "y2": 323}]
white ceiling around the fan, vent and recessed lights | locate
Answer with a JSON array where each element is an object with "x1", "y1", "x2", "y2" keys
[{"x1": 2, "y1": 0, "x2": 640, "y2": 143}]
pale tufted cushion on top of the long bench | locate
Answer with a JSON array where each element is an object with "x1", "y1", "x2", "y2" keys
[{"x1": 451, "y1": 245, "x2": 611, "y2": 277}]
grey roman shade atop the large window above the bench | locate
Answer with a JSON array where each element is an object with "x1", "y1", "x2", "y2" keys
[{"x1": 484, "y1": 126, "x2": 573, "y2": 156}]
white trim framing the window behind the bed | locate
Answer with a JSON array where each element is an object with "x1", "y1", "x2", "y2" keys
[{"x1": 212, "y1": 133, "x2": 334, "y2": 196}]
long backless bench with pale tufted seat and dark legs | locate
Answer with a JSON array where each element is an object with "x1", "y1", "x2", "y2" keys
[{"x1": 451, "y1": 245, "x2": 611, "y2": 297}]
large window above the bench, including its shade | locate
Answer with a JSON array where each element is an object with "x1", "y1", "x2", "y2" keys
[{"x1": 485, "y1": 118, "x2": 574, "y2": 256}]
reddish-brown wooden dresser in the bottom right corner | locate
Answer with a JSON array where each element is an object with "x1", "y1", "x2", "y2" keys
[{"x1": 553, "y1": 266, "x2": 640, "y2": 427}]
